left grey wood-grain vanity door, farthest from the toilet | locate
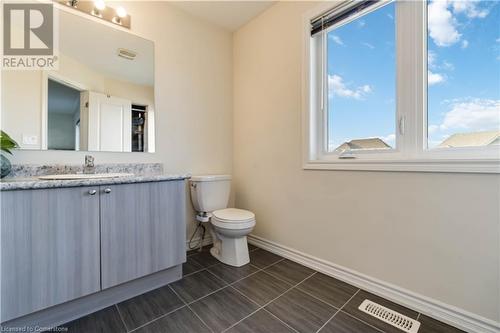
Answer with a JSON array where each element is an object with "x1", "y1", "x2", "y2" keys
[{"x1": 0, "y1": 187, "x2": 100, "y2": 321}]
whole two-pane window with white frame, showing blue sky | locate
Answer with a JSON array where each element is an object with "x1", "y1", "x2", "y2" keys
[{"x1": 304, "y1": 0, "x2": 500, "y2": 173}]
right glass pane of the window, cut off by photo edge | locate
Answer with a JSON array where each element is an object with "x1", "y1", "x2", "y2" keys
[{"x1": 427, "y1": 0, "x2": 500, "y2": 149}]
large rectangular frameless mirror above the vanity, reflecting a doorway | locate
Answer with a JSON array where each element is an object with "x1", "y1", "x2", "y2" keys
[{"x1": 2, "y1": 10, "x2": 155, "y2": 152}]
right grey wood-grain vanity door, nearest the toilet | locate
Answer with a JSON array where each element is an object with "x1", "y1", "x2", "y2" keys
[{"x1": 100, "y1": 181, "x2": 186, "y2": 289}]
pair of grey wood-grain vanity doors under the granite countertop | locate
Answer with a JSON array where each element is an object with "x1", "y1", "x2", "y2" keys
[{"x1": 0, "y1": 180, "x2": 186, "y2": 322}]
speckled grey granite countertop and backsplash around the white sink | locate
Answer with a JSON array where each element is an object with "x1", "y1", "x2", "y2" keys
[{"x1": 0, "y1": 163, "x2": 191, "y2": 191}]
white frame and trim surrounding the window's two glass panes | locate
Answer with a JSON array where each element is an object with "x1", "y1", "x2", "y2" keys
[{"x1": 302, "y1": 1, "x2": 500, "y2": 173}]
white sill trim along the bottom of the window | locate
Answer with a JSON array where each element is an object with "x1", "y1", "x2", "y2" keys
[{"x1": 303, "y1": 159, "x2": 500, "y2": 174}]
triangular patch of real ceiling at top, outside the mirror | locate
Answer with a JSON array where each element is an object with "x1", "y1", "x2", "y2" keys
[{"x1": 170, "y1": 0, "x2": 275, "y2": 31}]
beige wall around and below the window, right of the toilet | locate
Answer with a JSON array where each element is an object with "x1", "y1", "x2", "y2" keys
[{"x1": 233, "y1": 2, "x2": 500, "y2": 321}]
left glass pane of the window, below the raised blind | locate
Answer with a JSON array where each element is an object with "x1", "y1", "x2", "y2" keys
[{"x1": 326, "y1": 3, "x2": 396, "y2": 153}]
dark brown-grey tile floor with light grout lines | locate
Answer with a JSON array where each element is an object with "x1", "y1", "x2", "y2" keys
[{"x1": 63, "y1": 245, "x2": 462, "y2": 333}]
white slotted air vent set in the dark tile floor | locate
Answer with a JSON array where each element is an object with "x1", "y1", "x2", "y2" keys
[{"x1": 358, "y1": 299, "x2": 420, "y2": 333}]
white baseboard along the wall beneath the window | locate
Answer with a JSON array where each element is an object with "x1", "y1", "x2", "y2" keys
[{"x1": 248, "y1": 235, "x2": 500, "y2": 333}]
